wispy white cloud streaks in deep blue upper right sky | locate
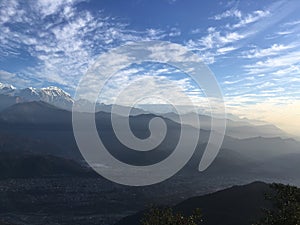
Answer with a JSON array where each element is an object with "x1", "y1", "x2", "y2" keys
[{"x1": 186, "y1": 9, "x2": 271, "y2": 62}]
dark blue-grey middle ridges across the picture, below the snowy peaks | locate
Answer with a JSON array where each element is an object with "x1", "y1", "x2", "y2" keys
[{"x1": 0, "y1": 101, "x2": 300, "y2": 181}]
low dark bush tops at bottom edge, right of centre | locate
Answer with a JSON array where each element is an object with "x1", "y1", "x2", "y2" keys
[{"x1": 141, "y1": 208, "x2": 202, "y2": 225}]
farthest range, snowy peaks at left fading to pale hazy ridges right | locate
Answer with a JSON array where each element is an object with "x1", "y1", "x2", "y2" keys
[{"x1": 0, "y1": 83, "x2": 298, "y2": 139}]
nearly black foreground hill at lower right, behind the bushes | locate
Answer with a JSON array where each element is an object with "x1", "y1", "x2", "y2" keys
[{"x1": 116, "y1": 182, "x2": 273, "y2": 225}]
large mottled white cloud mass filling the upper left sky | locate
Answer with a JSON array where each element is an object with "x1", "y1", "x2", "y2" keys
[{"x1": 0, "y1": 0, "x2": 166, "y2": 88}]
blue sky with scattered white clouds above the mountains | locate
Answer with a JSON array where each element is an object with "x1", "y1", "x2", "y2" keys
[{"x1": 0, "y1": 0, "x2": 300, "y2": 135}]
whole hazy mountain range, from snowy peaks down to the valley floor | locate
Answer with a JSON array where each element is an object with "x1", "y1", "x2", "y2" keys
[{"x1": 0, "y1": 84, "x2": 300, "y2": 182}]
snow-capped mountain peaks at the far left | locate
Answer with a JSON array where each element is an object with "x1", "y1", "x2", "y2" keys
[{"x1": 0, "y1": 83, "x2": 74, "y2": 109}]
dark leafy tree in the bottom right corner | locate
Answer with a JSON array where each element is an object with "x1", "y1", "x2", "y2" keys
[{"x1": 256, "y1": 184, "x2": 300, "y2": 225}]
